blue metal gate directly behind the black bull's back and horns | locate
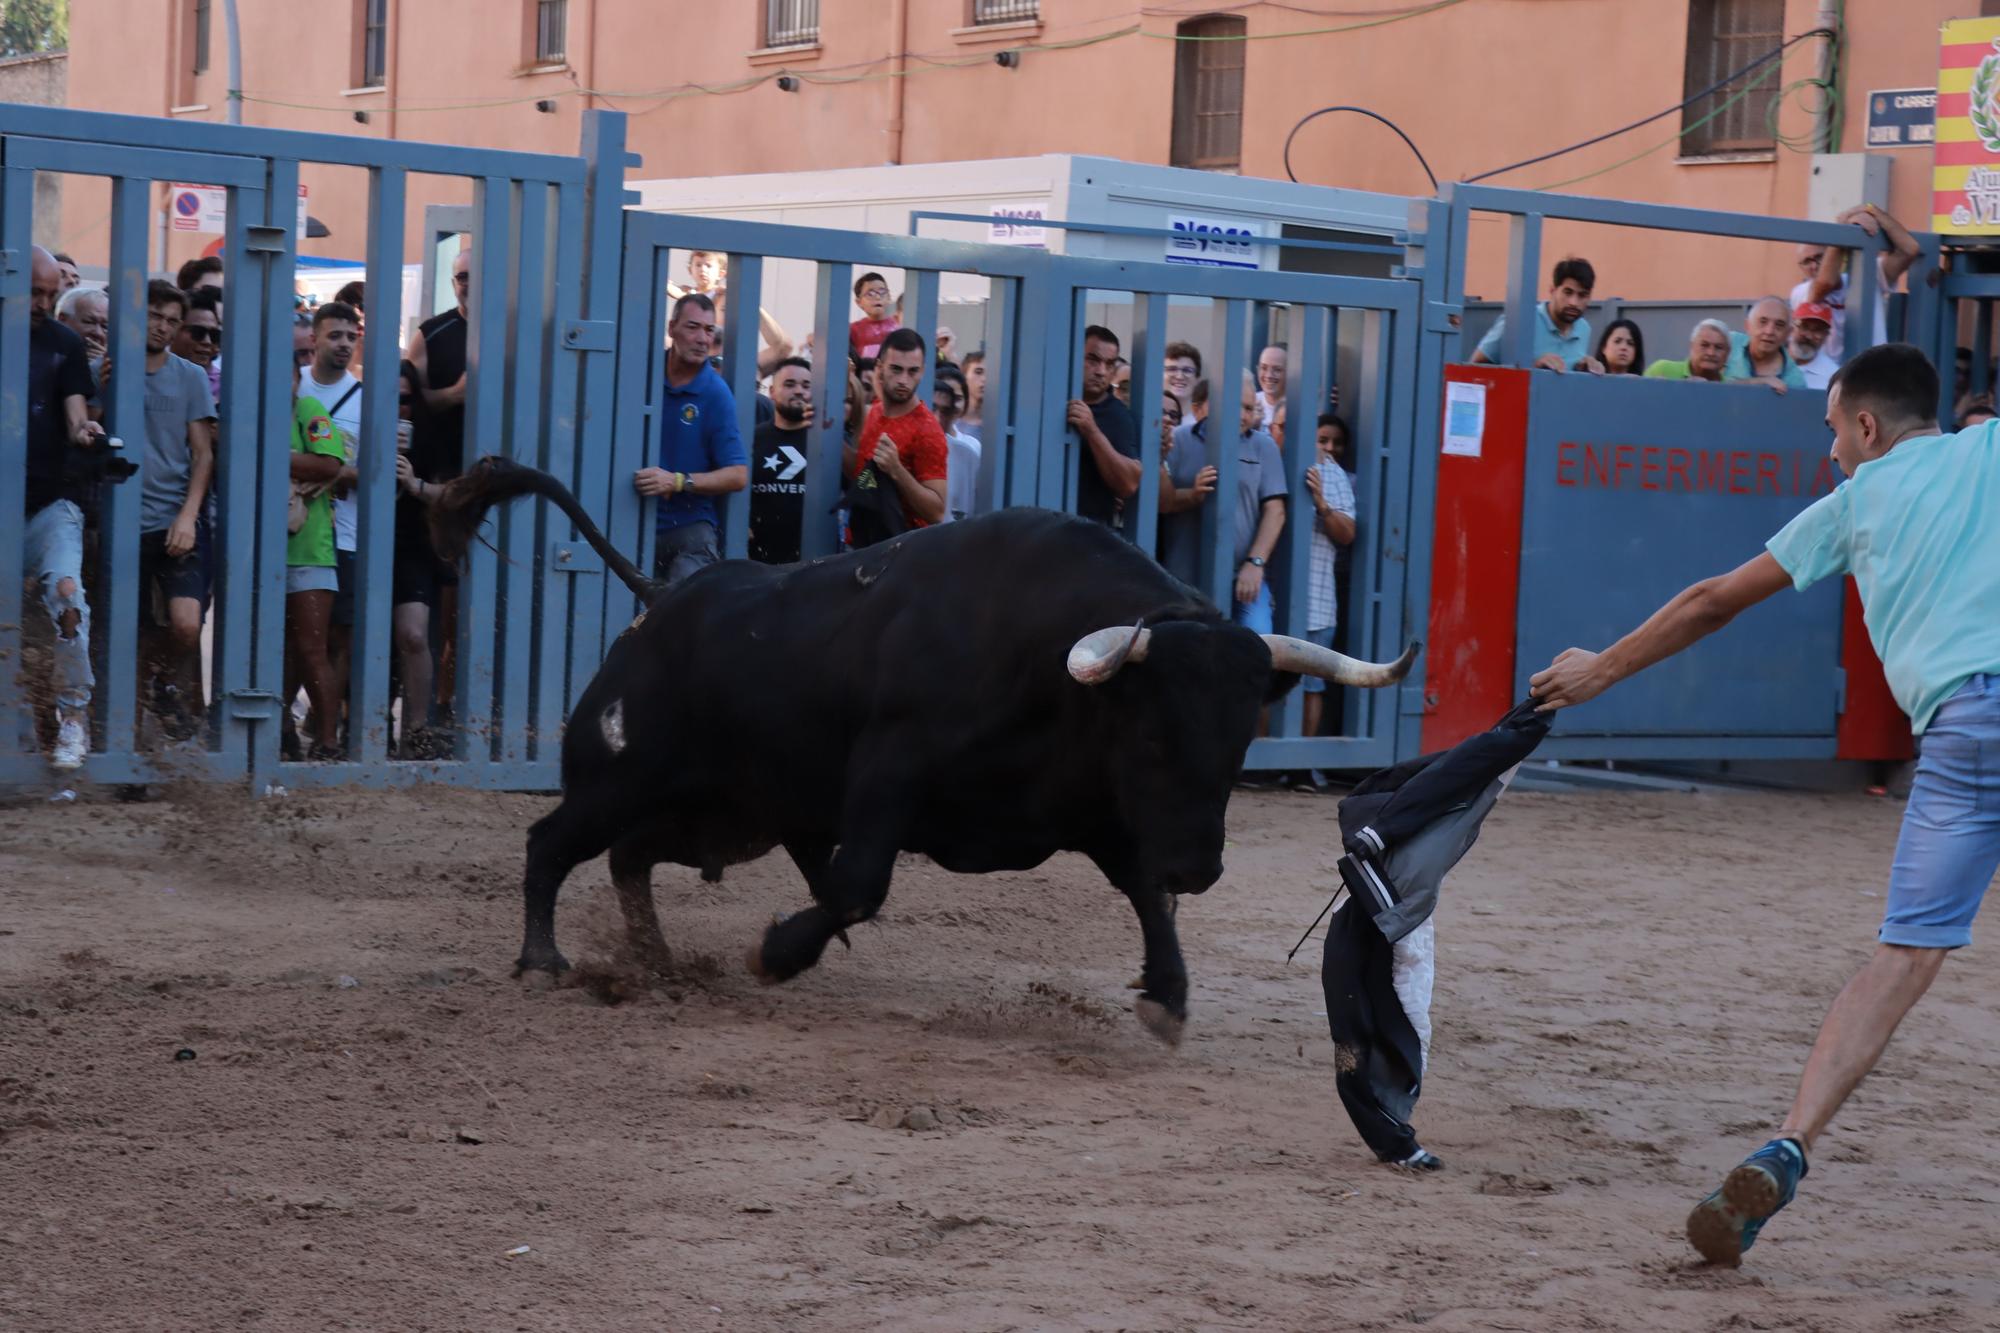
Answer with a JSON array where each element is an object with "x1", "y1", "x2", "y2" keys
[{"x1": 616, "y1": 212, "x2": 1434, "y2": 769}]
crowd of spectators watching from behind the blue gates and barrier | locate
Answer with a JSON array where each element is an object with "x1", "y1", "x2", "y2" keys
[{"x1": 22, "y1": 206, "x2": 1968, "y2": 769}]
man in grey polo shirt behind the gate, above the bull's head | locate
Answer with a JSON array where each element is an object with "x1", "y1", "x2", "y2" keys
[{"x1": 1160, "y1": 376, "x2": 1286, "y2": 634}]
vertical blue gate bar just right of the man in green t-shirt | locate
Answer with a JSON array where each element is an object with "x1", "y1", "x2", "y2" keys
[{"x1": 348, "y1": 166, "x2": 408, "y2": 763}]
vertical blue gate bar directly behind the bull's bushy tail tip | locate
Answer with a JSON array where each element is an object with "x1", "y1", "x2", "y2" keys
[{"x1": 458, "y1": 176, "x2": 514, "y2": 761}]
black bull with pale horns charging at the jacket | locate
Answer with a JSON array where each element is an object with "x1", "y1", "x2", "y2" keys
[{"x1": 432, "y1": 458, "x2": 1416, "y2": 1041}]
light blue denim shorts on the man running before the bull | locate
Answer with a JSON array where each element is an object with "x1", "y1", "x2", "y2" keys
[{"x1": 1880, "y1": 675, "x2": 2000, "y2": 949}]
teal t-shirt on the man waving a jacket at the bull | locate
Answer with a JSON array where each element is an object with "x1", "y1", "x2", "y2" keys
[{"x1": 1766, "y1": 420, "x2": 2000, "y2": 735}]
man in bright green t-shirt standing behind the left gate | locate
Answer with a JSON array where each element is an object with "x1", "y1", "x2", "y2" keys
[{"x1": 280, "y1": 390, "x2": 346, "y2": 761}]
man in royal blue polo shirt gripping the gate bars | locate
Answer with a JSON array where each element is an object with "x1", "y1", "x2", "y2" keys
[{"x1": 632, "y1": 292, "x2": 750, "y2": 584}]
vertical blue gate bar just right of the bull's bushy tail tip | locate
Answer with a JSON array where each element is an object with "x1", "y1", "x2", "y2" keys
[{"x1": 498, "y1": 180, "x2": 550, "y2": 765}]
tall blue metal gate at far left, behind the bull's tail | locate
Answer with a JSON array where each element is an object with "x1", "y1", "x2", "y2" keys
[{"x1": 0, "y1": 106, "x2": 628, "y2": 789}]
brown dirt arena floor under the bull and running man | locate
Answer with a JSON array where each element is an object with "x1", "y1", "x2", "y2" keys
[{"x1": 0, "y1": 791, "x2": 2000, "y2": 1333}]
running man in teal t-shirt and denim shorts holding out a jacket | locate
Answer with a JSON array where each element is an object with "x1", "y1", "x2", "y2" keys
[{"x1": 1530, "y1": 342, "x2": 2000, "y2": 1263}]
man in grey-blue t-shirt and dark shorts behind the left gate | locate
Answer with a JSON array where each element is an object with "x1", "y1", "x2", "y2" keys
[{"x1": 115, "y1": 280, "x2": 216, "y2": 741}]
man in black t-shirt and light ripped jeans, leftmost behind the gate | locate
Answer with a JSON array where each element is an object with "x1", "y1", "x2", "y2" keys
[{"x1": 22, "y1": 246, "x2": 104, "y2": 769}]
